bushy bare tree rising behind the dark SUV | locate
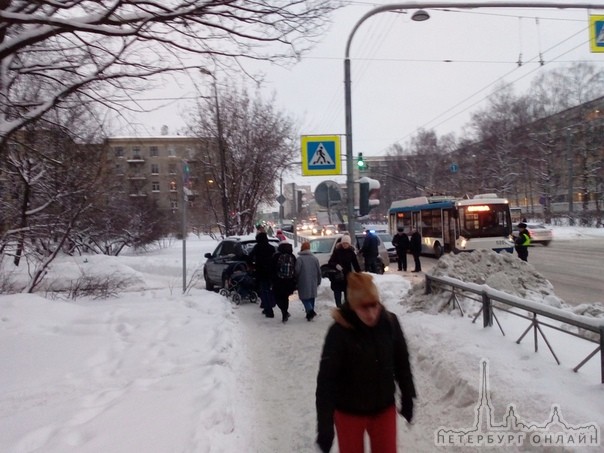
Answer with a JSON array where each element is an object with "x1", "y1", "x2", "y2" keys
[{"x1": 189, "y1": 85, "x2": 296, "y2": 233}]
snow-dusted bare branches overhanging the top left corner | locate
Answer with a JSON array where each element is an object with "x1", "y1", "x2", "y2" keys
[{"x1": 0, "y1": 0, "x2": 339, "y2": 145}]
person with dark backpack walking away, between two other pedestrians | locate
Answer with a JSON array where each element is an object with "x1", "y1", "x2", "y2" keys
[{"x1": 272, "y1": 241, "x2": 296, "y2": 323}]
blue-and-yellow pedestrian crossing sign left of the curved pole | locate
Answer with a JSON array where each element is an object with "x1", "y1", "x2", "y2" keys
[{"x1": 302, "y1": 135, "x2": 342, "y2": 176}]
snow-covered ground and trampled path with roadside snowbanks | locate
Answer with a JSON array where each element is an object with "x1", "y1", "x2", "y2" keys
[{"x1": 0, "y1": 228, "x2": 604, "y2": 453}]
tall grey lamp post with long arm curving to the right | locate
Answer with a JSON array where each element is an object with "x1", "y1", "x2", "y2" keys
[{"x1": 344, "y1": 1, "x2": 602, "y2": 234}]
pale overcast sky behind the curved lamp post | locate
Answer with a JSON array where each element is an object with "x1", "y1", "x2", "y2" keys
[{"x1": 109, "y1": 1, "x2": 604, "y2": 188}]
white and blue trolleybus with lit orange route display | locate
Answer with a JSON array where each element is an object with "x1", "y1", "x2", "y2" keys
[{"x1": 388, "y1": 194, "x2": 514, "y2": 257}]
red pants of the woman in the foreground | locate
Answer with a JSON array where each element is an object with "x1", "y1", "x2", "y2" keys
[{"x1": 334, "y1": 404, "x2": 396, "y2": 453}]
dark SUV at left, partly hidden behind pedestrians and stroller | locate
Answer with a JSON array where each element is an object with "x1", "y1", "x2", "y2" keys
[{"x1": 203, "y1": 236, "x2": 279, "y2": 291}]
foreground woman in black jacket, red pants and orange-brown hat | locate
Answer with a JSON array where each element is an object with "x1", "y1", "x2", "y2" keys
[{"x1": 315, "y1": 272, "x2": 416, "y2": 453}]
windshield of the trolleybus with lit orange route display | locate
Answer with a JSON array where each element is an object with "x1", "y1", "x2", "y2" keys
[{"x1": 458, "y1": 204, "x2": 512, "y2": 239}]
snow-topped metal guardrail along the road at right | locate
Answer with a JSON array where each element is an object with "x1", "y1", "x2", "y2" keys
[{"x1": 425, "y1": 274, "x2": 604, "y2": 384}]
